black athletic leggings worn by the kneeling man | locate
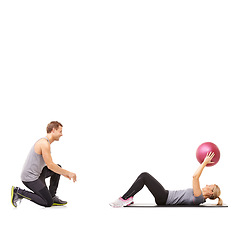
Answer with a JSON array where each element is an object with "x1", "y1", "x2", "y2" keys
[{"x1": 18, "y1": 165, "x2": 61, "y2": 207}]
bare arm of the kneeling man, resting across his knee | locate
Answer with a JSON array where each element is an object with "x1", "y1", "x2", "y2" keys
[{"x1": 41, "y1": 141, "x2": 77, "y2": 182}]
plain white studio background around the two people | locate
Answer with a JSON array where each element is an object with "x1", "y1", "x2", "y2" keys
[{"x1": 0, "y1": 0, "x2": 240, "y2": 239}]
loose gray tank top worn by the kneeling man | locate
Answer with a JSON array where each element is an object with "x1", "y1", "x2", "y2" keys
[{"x1": 21, "y1": 137, "x2": 49, "y2": 182}]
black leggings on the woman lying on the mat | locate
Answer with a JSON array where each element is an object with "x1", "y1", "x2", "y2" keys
[{"x1": 122, "y1": 172, "x2": 168, "y2": 205}]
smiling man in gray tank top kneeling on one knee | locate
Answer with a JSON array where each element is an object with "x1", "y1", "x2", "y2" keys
[{"x1": 11, "y1": 121, "x2": 76, "y2": 207}]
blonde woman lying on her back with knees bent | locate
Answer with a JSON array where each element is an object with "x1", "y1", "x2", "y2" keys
[{"x1": 110, "y1": 152, "x2": 222, "y2": 207}]
